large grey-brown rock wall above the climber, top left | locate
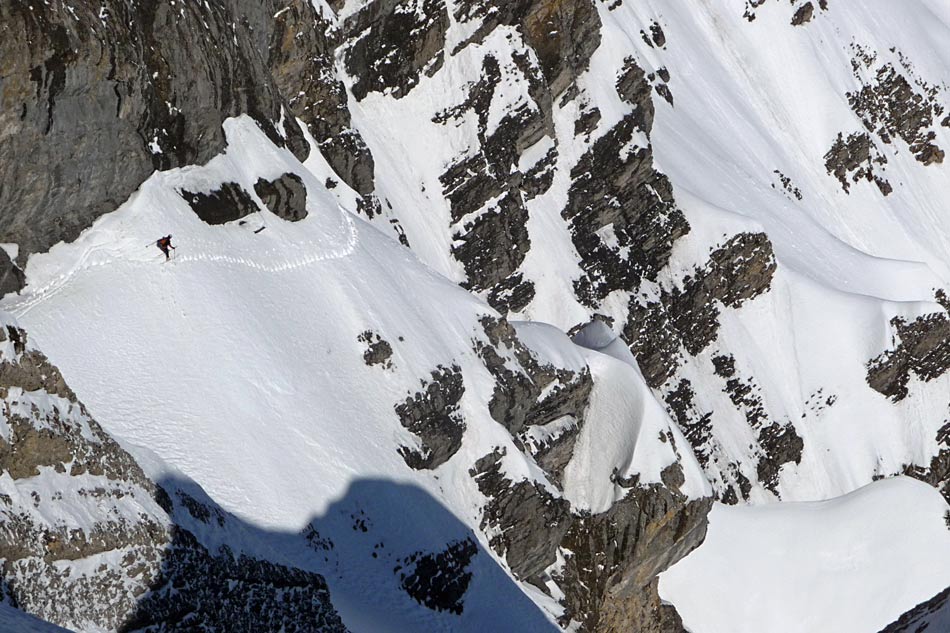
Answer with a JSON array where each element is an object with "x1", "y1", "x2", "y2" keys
[{"x1": 0, "y1": 1, "x2": 308, "y2": 270}]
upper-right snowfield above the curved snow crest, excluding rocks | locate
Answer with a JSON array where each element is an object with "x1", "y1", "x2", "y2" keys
[{"x1": 648, "y1": 0, "x2": 950, "y2": 300}]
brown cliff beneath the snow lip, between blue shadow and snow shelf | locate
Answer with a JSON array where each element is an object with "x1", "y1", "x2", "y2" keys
[{"x1": 472, "y1": 444, "x2": 712, "y2": 631}]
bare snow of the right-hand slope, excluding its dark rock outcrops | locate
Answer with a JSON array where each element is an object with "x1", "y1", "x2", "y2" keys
[{"x1": 604, "y1": 0, "x2": 950, "y2": 501}]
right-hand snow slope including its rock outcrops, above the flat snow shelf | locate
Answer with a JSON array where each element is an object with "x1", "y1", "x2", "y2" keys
[{"x1": 637, "y1": 0, "x2": 950, "y2": 499}]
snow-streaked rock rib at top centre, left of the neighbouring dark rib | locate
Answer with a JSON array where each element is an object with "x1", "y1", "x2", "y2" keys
[{"x1": 424, "y1": 0, "x2": 600, "y2": 312}]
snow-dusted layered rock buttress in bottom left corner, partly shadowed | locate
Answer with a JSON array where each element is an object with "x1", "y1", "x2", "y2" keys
[{"x1": 0, "y1": 317, "x2": 345, "y2": 631}]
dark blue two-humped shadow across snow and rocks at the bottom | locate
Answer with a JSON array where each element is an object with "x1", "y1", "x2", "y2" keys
[{"x1": 121, "y1": 472, "x2": 557, "y2": 633}]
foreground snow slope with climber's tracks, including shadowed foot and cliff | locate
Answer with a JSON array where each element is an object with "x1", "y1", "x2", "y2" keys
[{"x1": 3, "y1": 119, "x2": 709, "y2": 631}]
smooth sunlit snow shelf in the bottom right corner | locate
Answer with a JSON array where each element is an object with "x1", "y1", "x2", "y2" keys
[{"x1": 660, "y1": 477, "x2": 950, "y2": 633}]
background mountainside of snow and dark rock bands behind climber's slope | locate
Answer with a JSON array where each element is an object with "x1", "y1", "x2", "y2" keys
[{"x1": 332, "y1": 0, "x2": 950, "y2": 501}]
